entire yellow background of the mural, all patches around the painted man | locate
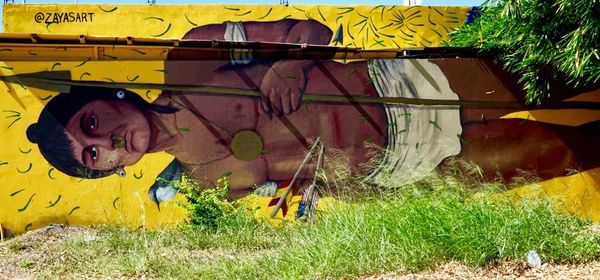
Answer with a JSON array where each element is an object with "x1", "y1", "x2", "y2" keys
[{"x1": 0, "y1": 4, "x2": 600, "y2": 233}]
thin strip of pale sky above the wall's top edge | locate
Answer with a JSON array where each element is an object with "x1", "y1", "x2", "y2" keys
[{"x1": 0, "y1": 0, "x2": 484, "y2": 31}]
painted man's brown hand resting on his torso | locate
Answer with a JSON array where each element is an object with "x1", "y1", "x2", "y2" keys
[{"x1": 260, "y1": 60, "x2": 306, "y2": 116}]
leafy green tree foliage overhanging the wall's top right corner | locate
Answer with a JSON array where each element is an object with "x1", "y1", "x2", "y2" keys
[{"x1": 450, "y1": 0, "x2": 600, "y2": 103}]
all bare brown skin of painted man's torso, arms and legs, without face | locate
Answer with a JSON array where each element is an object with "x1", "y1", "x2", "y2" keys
[{"x1": 68, "y1": 20, "x2": 598, "y2": 198}]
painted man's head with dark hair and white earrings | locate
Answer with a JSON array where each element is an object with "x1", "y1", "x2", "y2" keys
[{"x1": 27, "y1": 87, "x2": 176, "y2": 178}]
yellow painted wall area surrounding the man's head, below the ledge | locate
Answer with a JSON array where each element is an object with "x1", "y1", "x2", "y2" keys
[{"x1": 0, "y1": 61, "x2": 184, "y2": 232}]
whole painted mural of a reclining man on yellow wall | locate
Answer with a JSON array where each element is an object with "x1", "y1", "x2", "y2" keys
[{"x1": 0, "y1": 5, "x2": 600, "y2": 232}]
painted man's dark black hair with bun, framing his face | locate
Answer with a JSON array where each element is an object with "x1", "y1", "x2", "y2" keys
[{"x1": 27, "y1": 86, "x2": 179, "y2": 179}]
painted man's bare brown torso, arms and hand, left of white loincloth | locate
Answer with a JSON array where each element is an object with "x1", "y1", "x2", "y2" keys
[{"x1": 163, "y1": 20, "x2": 387, "y2": 197}]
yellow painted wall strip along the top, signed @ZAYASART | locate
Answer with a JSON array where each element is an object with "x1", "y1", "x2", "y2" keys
[{"x1": 4, "y1": 4, "x2": 470, "y2": 48}]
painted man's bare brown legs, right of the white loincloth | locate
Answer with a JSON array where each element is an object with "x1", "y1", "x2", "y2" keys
[{"x1": 432, "y1": 59, "x2": 600, "y2": 181}]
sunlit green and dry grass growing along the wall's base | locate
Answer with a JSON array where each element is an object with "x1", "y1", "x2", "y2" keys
[{"x1": 14, "y1": 174, "x2": 600, "y2": 279}]
